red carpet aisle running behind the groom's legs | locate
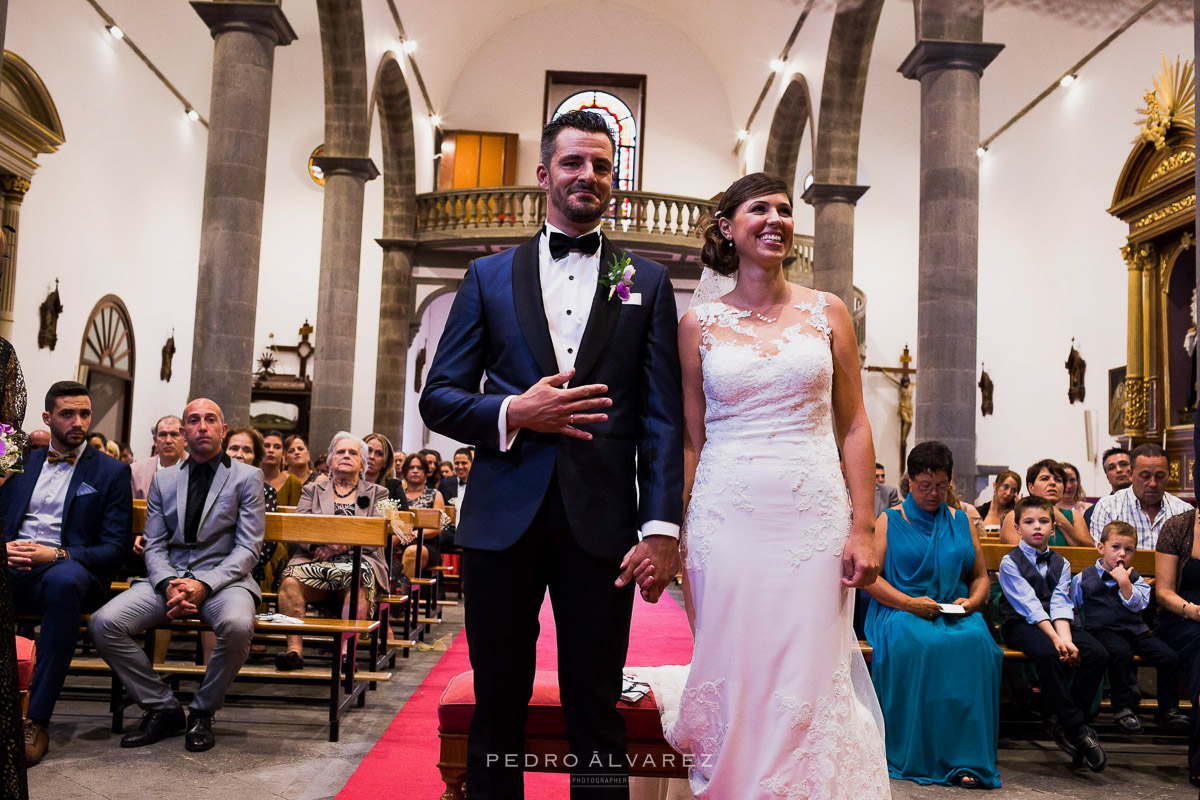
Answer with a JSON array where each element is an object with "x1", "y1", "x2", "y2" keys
[{"x1": 337, "y1": 596, "x2": 691, "y2": 800}]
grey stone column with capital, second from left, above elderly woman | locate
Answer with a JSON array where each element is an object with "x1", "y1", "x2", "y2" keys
[{"x1": 308, "y1": 156, "x2": 379, "y2": 452}]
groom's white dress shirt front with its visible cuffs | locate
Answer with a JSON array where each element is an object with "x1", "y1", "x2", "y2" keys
[{"x1": 487, "y1": 222, "x2": 679, "y2": 539}]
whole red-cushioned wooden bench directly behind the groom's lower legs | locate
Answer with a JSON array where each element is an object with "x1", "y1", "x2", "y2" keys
[{"x1": 438, "y1": 670, "x2": 690, "y2": 800}]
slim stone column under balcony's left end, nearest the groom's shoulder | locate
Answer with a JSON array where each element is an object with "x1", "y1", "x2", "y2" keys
[{"x1": 374, "y1": 239, "x2": 416, "y2": 447}]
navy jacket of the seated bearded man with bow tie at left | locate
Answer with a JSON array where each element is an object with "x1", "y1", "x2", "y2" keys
[{"x1": 0, "y1": 447, "x2": 133, "y2": 588}]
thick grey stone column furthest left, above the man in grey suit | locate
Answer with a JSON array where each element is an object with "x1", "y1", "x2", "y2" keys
[{"x1": 188, "y1": 0, "x2": 296, "y2": 423}]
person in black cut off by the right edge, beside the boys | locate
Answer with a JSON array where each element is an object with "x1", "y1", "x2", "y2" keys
[{"x1": 1152, "y1": 463, "x2": 1200, "y2": 786}]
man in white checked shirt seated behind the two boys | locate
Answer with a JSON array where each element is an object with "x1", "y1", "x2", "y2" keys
[{"x1": 1092, "y1": 444, "x2": 1192, "y2": 549}]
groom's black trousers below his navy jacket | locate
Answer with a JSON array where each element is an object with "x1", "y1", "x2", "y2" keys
[{"x1": 462, "y1": 479, "x2": 634, "y2": 800}]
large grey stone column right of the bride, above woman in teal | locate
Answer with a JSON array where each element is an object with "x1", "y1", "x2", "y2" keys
[{"x1": 900, "y1": 6, "x2": 1003, "y2": 499}]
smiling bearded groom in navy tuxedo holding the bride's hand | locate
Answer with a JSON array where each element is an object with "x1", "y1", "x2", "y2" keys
[{"x1": 420, "y1": 112, "x2": 683, "y2": 800}]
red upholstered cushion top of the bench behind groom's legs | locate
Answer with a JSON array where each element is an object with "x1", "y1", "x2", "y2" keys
[{"x1": 438, "y1": 670, "x2": 662, "y2": 741}]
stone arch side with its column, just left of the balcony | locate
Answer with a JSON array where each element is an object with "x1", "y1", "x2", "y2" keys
[{"x1": 371, "y1": 53, "x2": 420, "y2": 446}]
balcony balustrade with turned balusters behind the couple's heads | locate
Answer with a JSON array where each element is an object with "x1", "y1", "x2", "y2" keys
[{"x1": 416, "y1": 186, "x2": 812, "y2": 279}]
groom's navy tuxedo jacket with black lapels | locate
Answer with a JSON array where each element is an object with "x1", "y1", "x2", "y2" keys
[{"x1": 420, "y1": 231, "x2": 683, "y2": 558}]
